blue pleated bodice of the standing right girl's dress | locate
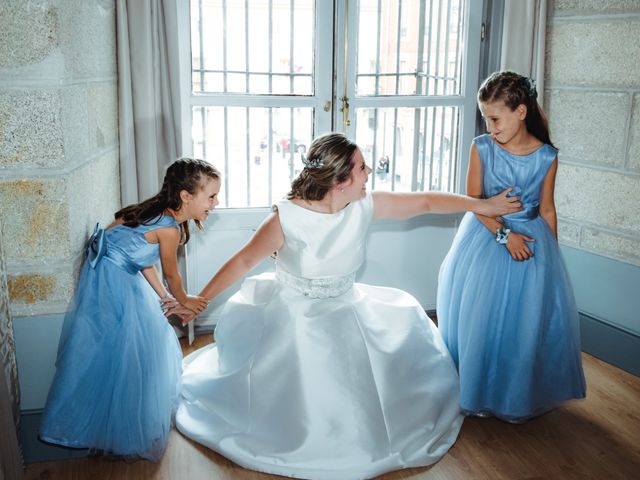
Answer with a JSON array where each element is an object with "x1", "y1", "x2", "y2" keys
[{"x1": 473, "y1": 134, "x2": 558, "y2": 221}]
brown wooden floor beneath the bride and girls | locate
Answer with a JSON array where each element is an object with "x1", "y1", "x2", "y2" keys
[{"x1": 26, "y1": 335, "x2": 640, "y2": 480}]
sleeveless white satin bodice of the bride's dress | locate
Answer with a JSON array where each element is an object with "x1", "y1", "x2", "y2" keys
[{"x1": 277, "y1": 193, "x2": 373, "y2": 279}]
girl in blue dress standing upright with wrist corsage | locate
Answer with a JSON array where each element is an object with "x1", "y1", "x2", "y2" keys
[{"x1": 437, "y1": 71, "x2": 585, "y2": 422}]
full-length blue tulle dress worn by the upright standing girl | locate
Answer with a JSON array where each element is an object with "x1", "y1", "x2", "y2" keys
[{"x1": 437, "y1": 135, "x2": 585, "y2": 421}]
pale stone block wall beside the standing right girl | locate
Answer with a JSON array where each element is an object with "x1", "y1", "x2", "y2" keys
[{"x1": 545, "y1": 0, "x2": 640, "y2": 265}]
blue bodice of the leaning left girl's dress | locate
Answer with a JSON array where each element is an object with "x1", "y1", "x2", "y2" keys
[{"x1": 99, "y1": 215, "x2": 179, "y2": 273}]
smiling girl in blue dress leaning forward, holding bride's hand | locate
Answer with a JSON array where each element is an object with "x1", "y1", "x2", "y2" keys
[{"x1": 40, "y1": 159, "x2": 220, "y2": 461}]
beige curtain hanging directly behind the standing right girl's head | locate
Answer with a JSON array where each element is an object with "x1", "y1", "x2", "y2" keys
[{"x1": 500, "y1": 0, "x2": 547, "y2": 105}]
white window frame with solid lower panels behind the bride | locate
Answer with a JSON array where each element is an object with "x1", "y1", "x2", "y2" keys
[{"x1": 177, "y1": 0, "x2": 491, "y2": 334}]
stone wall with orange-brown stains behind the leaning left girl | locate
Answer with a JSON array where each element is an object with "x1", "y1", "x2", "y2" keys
[{"x1": 0, "y1": 0, "x2": 120, "y2": 323}]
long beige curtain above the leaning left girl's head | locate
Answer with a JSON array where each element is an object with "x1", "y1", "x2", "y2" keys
[{"x1": 116, "y1": 0, "x2": 182, "y2": 205}]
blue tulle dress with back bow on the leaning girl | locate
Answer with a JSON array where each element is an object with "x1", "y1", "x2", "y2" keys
[{"x1": 40, "y1": 216, "x2": 182, "y2": 461}]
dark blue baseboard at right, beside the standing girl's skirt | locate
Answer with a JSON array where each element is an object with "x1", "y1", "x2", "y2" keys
[{"x1": 580, "y1": 312, "x2": 640, "y2": 376}]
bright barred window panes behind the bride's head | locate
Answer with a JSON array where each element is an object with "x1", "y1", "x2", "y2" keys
[{"x1": 180, "y1": 0, "x2": 482, "y2": 208}]
